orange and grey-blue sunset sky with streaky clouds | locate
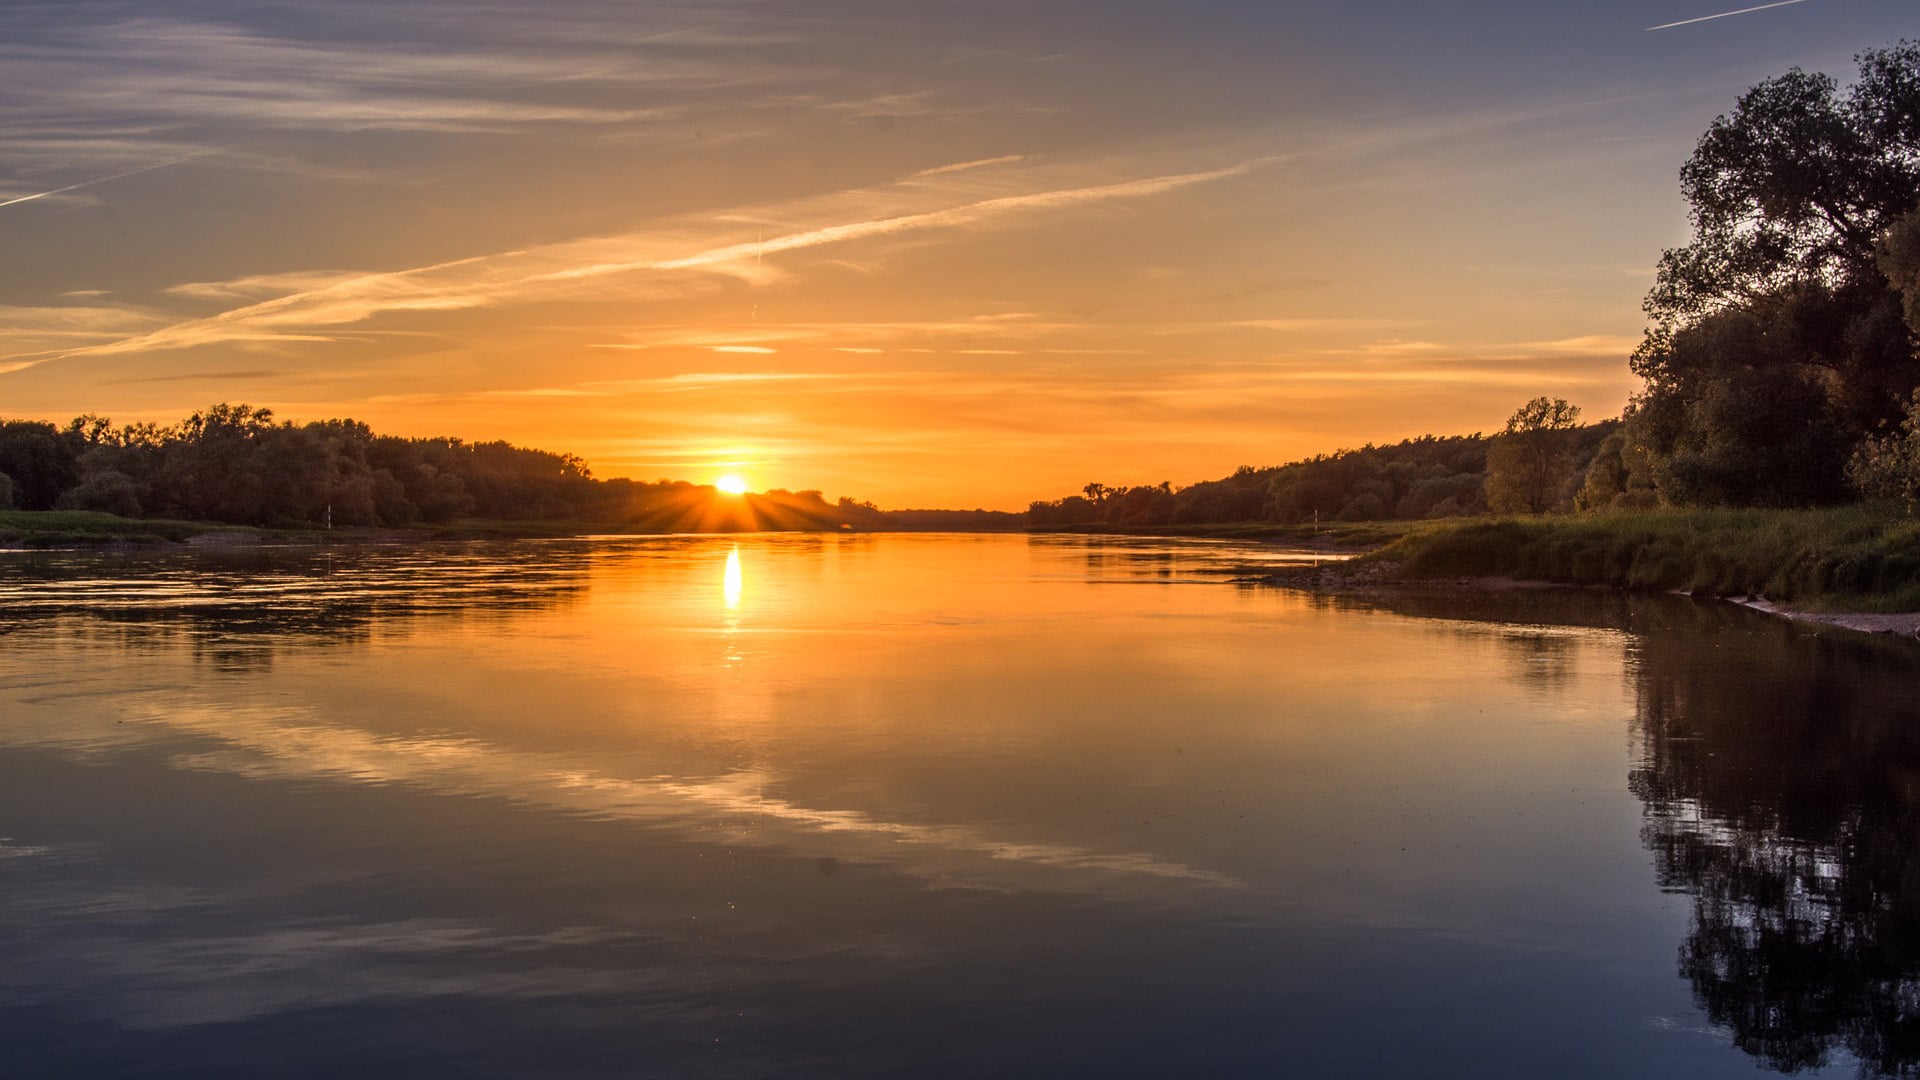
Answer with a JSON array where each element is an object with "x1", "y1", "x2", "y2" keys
[{"x1": 0, "y1": 0, "x2": 1920, "y2": 509}]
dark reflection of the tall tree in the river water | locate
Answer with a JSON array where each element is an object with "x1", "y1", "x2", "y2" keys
[{"x1": 1630, "y1": 621, "x2": 1920, "y2": 1076}]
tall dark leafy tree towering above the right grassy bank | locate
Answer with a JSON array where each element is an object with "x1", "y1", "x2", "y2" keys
[{"x1": 1632, "y1": 42, "x2": 1920, "y2": 505}]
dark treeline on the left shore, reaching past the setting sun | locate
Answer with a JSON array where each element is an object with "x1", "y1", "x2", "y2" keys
[{"x1": 0, "y1": 404, "x2": 1020, "y2": 532}]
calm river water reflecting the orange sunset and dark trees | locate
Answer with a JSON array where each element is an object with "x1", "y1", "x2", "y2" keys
[{"x1": 0, "y1": 536, "x2": 1920, "y2": 1078}]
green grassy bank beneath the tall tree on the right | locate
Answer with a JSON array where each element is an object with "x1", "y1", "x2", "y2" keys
[{"x1": 1371, "y1": 505, "x2": 1920, "y2": 611}]
